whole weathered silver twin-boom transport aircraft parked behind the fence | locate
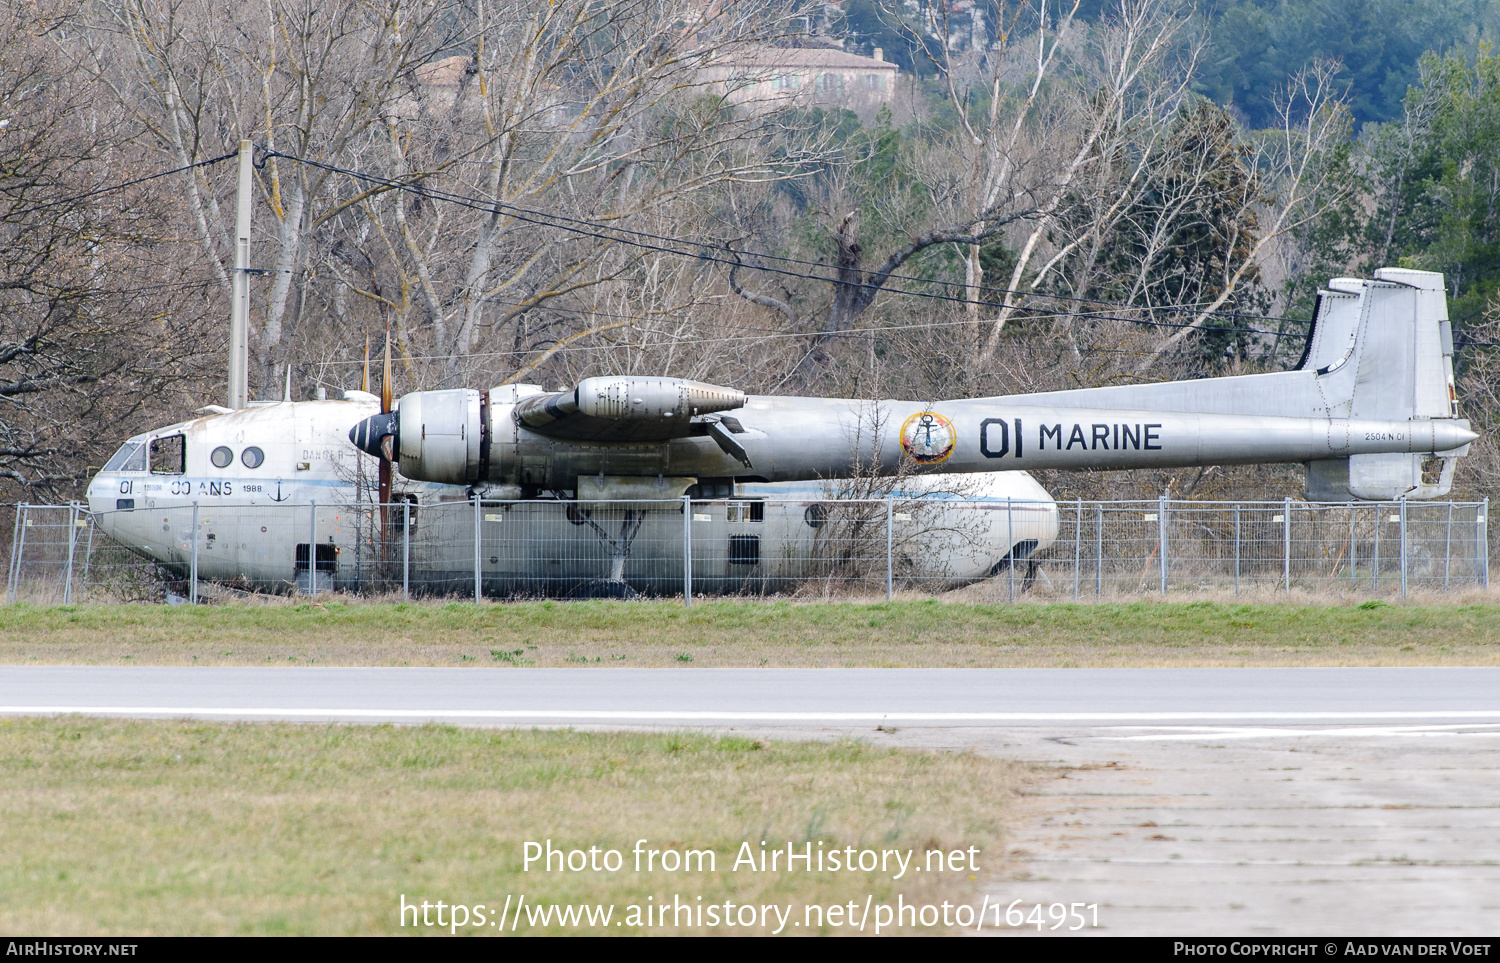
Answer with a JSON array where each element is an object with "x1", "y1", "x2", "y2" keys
[{"x1": 89, "y1": 269, "x2": 1476, "y2": 594}]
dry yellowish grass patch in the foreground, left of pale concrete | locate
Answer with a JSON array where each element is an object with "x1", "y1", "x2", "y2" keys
[{"x1": 0, "y1": 719, "x2": 1031, "y2": 935}]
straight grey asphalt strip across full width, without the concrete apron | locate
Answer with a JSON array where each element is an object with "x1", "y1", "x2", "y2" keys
[{"x1": 0, "y1": 666, "x2": 1500, "y2": 726}]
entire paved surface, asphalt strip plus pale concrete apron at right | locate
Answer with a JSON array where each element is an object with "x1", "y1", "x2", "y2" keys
[{"x1": 0, "y1": 666, "x2": 1500, "y2": 938}]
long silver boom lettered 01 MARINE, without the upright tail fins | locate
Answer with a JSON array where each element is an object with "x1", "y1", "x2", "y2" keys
[{"x1": 390, "y1": 396, "x2": 1476, "y2": 489}]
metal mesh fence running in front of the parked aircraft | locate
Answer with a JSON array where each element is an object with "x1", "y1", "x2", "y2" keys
[{"x1": 0, "y1": 497, "x2": 1490, "y2": 603}]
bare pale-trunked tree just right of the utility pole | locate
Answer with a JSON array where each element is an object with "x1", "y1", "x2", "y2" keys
[{"x1": 72, "y1": 0, "x2": 455, "y2": 392}]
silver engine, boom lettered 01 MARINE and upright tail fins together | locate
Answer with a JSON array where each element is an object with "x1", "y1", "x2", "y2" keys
[{"x1": 369, "y1": 269, "x2": 1478, "y2": 500}]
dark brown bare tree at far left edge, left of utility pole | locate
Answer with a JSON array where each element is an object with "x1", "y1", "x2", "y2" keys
[{"x1": 0, "y1": 5, "x2": 212, "y2": 498}]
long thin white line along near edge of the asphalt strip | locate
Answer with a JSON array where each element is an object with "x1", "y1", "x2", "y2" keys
[{"x1": 0, "y1": 705, "x2": 1500, "y2": 717}]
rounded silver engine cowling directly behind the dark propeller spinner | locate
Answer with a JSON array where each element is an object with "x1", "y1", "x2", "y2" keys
[{"x1": 396, "y1": 389, "x2": 489, "y2": 485}]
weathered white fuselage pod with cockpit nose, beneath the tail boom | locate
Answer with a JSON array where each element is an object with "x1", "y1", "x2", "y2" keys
[{"x1": 89, "y1": 392, "x2": 1058, "y2": 596}]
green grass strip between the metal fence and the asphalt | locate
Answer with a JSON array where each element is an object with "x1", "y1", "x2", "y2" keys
[{"x1": 0, "y1": 602, "x2": 1500, "y2": 668}]
